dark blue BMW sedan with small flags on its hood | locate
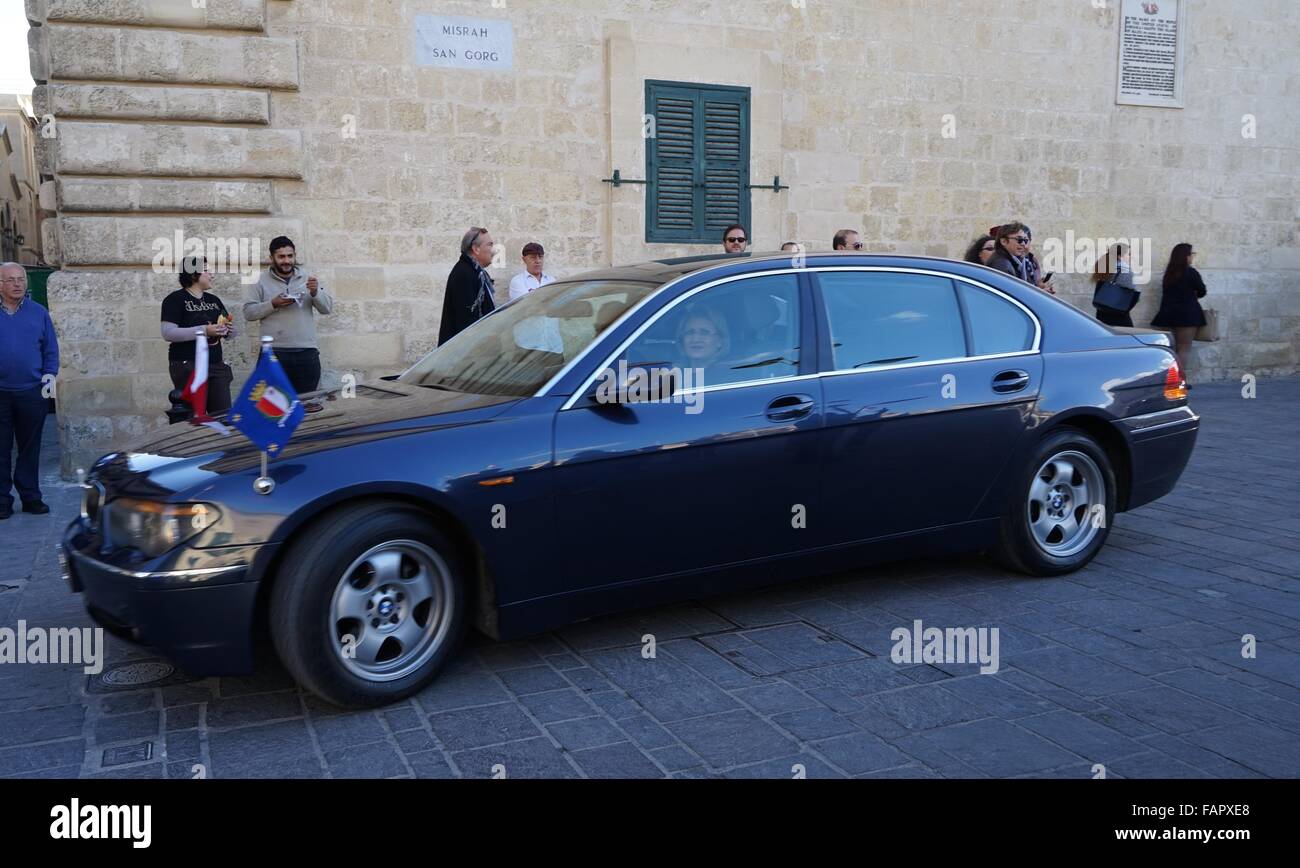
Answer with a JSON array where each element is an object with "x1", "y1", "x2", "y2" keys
[{"x1": 62, "y1": 255, "x2": 1199, "y2": 706}]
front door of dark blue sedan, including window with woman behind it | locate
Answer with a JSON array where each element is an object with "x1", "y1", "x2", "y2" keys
[{"x1": 554, "y1": 272, "x2": 823, "y2": 597}]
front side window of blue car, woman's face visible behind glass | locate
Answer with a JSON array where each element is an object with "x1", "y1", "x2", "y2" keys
[{"x1": 619, "y1": 274, "x2": 800, "y2": 386}]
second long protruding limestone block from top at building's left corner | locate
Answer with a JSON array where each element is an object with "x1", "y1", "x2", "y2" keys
[{"x1": 56, "y1": 121, "x2": 303, "y2": 178}]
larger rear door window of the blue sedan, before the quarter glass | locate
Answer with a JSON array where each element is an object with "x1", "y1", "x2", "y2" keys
[{"x1": 818, "y1": 272, "x2": 966, "y2": 370}]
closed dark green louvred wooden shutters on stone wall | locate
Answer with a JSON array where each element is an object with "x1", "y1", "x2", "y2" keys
[{"x1": 646, "y1": 82, "x2": 750, "y2": 246}]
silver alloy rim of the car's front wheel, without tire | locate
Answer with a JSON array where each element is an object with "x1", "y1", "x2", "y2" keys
[{"x1": 329, "y1": 539, "x2": 455, "y2": 681}]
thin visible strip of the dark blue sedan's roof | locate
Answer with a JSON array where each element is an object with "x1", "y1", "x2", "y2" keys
[{"x1": 563, "y1": 251, "x2": 998, "y2": 285}]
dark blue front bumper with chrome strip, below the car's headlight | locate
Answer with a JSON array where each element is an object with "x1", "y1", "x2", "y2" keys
[{"x1": 60, "y1": 521, "x2": 266, "y2": 676}]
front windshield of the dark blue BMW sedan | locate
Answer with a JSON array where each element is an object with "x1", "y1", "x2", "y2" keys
[{"x1": 398, "y1": 281, "x2": 659, "y2": 398}]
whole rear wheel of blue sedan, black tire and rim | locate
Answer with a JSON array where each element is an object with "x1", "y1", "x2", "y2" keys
[{"x1": 993, "y1": 428, "x2": 1117, "y2": 576}]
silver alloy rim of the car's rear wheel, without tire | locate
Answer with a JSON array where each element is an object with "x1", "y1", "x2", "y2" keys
[{"x1": 1026, "y1": 450, "x2": 1109, "y2": 557}]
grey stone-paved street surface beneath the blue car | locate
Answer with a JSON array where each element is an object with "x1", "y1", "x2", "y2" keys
[{"x1": 0, "y1": 379, "x2": 1300, "y2": 778}]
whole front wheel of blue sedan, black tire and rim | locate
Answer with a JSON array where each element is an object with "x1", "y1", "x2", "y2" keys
[{"x1": 270, "y1": 503, "x2": 471, "y2": 708}]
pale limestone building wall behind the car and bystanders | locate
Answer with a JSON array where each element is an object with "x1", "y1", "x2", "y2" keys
[{"x1": 27, "y1": 0, "x2": 1300, "y2": 470}]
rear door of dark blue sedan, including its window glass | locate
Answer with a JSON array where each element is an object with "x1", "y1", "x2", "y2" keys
[{"x1": 815, "y1": 269, "x2": 1043, "y2": 542}]
